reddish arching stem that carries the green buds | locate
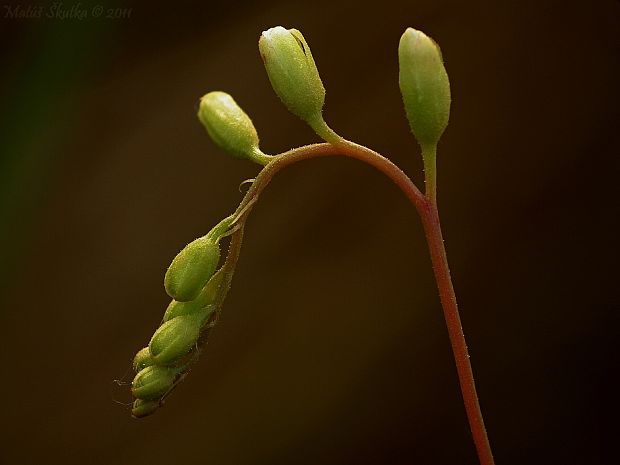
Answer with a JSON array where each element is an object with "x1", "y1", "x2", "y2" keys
[{"x1": 231, "y1": 139, "x2": 494, "y2": 465}]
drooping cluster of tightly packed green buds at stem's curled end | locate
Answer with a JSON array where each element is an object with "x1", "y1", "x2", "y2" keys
[{"x1": 131, "y1": 216, "x2": 234, "y2": 418}]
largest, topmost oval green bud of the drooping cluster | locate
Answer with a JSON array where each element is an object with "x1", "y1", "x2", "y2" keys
[{"x1": 164, "y1": 234, "x2": 220, "y2": 302}]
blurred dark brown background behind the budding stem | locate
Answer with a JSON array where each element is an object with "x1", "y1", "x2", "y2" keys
[{"x1": 0, "y1": 0, "x2": 620, "y2": 465}]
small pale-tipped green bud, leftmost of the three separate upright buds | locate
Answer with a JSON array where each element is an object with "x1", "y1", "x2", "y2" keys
[{"x1": 198, "y1": 92, "x2": 270, "y2": 165}]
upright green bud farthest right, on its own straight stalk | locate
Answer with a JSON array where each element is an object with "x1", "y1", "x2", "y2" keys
[{"x1": 398, "y1": 28, "x2": 450, "y2": 146}]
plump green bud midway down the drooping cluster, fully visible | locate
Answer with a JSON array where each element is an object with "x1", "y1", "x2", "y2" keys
[{"x1": 149, "y1": 315, "x2": 201, "y2": 365}]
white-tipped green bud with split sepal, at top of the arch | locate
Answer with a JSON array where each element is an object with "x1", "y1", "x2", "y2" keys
[{"x1": 258, "y1": 26, "x2": 325, "y2": 124}]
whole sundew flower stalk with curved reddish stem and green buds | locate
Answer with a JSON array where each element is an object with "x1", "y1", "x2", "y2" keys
[{"x1": 131, "y1": 26, "x2": 494, "y2": 465}]
